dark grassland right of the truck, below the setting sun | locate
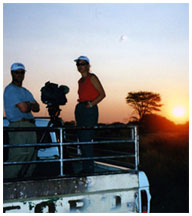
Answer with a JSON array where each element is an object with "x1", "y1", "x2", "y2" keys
[{"x1": 140, "y1": 130, "x2": 189, "y2": 213}]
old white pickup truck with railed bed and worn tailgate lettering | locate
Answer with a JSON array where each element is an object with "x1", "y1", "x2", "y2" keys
[{"x1": 3, "y1": 118, "x2": 151, "y2": 213}]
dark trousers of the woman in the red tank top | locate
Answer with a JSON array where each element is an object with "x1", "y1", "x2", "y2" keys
[{"x1": 75, "y1": 103, "x2": 98, "y2": 173}]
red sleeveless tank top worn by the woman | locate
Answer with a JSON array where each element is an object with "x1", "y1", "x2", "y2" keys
[{"x1": 78, "y1": 75, "x2": 99, "y2": 102}]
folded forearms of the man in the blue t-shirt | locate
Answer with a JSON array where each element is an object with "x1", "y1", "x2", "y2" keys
[{"x1": 16, "y1": 101, "x2": 40, "y2": 113}]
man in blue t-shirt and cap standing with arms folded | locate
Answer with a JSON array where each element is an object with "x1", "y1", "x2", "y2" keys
[{"x1": 4, "y1": 63, "x2": 39, "y2": 178}]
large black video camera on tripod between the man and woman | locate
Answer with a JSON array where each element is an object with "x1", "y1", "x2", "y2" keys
[{"x1": 41, "y1": 81, "x2": 69, "y2": 107}]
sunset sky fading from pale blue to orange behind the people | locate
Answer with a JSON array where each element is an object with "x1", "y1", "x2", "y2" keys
[{"x1": 3, "y1": 3, "x2": 189, "y2": 123}]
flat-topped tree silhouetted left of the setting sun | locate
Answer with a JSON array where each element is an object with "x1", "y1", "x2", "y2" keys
[{"x1": 126, "y1": 91, "x2": 162, "y2": 120}]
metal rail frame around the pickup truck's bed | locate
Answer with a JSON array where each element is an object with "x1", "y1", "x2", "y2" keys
[{"x1": 3, "y1": 125, "x2": 139, "y2": 176}]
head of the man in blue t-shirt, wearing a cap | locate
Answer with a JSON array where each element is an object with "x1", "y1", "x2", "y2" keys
[{"x1": 11, "y1": 63, "x2": 26, "y2": 85}]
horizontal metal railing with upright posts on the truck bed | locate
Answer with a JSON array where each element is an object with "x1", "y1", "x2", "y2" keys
[{"x1": 3, "y1": 125, "x2": 139, "y2": 176}]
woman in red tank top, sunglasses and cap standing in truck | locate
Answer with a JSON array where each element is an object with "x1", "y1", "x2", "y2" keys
[{"x1": 74, "y1": 56, "x2": 106, "y2": 173}]
